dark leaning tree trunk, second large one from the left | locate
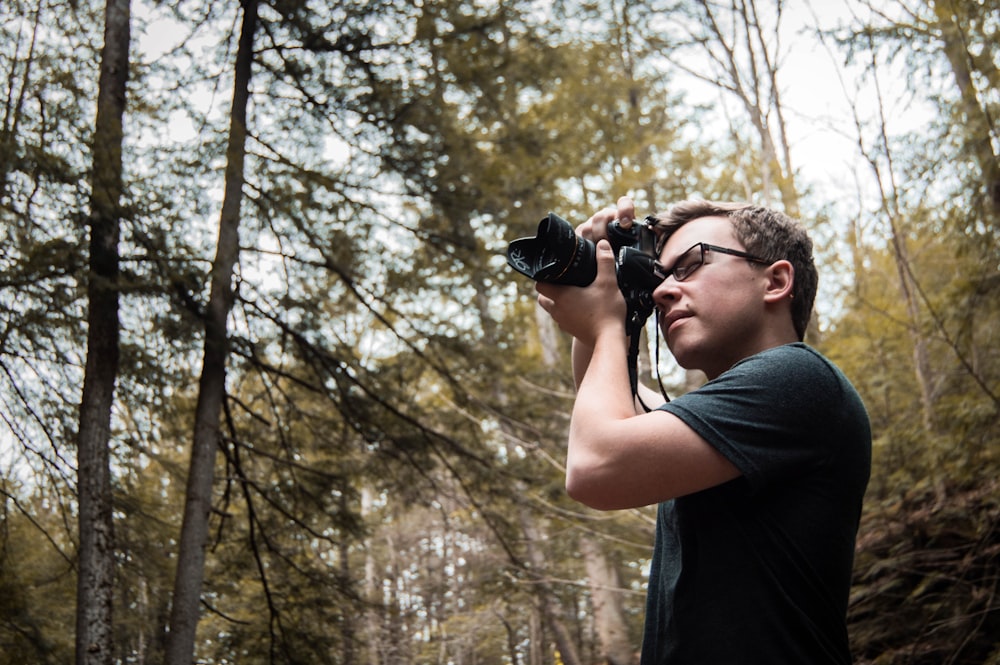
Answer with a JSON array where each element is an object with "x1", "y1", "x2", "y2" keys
[{"x1": 165, "y1": 0, "x2": 257, "y2": 665}]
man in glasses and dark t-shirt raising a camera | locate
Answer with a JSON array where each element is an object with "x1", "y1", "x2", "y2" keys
[{"x1": 536, "y1": 198, "x2": 871, "y2": 665}]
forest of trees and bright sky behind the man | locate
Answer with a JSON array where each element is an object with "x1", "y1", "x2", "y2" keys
[{"x1": 0, "y1": 0, "x2": 1000, "y2": 665}]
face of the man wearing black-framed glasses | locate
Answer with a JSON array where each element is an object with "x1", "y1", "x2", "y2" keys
[{"x1": 653, "y1": 217, "x2": 767, "y2": 379}]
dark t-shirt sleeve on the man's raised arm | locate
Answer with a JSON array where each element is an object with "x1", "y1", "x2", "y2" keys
[{"x1": 660, "y1": 344, "x2": 845, "y2": 490}]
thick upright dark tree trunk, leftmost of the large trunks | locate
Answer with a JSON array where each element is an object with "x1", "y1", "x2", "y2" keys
[{"x1": 76, "y1": 0, "x2": 130, "y2": 665}]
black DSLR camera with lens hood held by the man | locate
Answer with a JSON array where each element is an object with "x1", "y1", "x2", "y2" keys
[{"x1": 507, "y1": 212, "x2": 663, "y2": 337}]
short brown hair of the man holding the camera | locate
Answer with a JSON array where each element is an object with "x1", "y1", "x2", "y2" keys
[{"x1": 652, "y1": 201, "x2": 819, "y2": 340}]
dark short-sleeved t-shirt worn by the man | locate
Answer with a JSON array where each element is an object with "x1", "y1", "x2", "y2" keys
[{"x1": 642, "y1": 344, "x2": 871, "y2": 665}]
